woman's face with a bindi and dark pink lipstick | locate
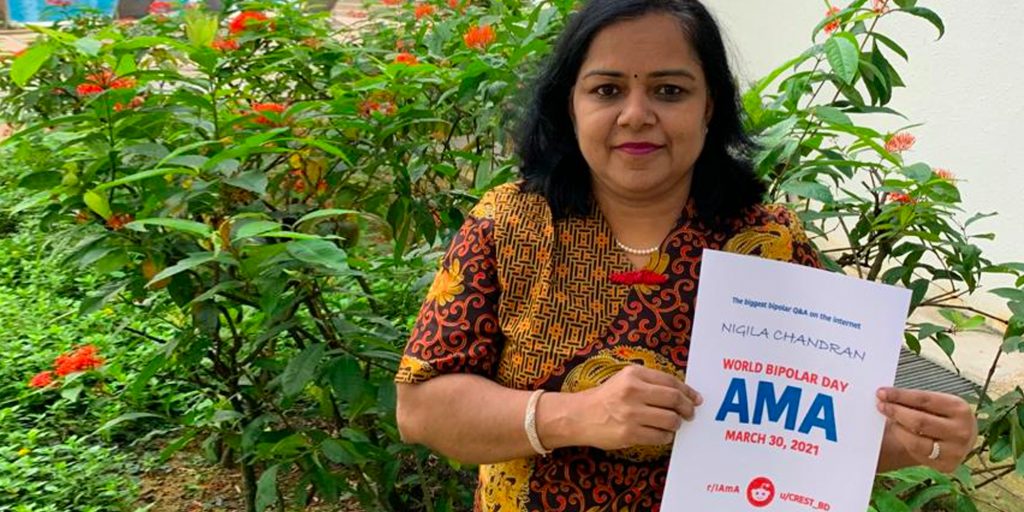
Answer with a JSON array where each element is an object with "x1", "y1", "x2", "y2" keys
[{"x1": 571, "y1": 13, "x2": 713, "y2": 200}]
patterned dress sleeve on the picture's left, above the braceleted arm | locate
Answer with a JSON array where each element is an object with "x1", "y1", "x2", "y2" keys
[{"x1": 395, "y1": 209, "x2": 504, "y2": 384}]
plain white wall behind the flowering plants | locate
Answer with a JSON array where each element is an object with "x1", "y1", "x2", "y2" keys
[{"x1": 705, "y1": 0, "x2": 1024, "y2": 307}]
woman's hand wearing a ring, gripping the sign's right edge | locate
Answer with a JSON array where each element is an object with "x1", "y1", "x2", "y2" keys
[{"x1": 878, "y1": 388, "x2": 978, "y2": 473}]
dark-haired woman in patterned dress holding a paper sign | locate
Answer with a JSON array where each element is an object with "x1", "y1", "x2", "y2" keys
[{"x1": 396, "y1": 0, "x2": 975, "y2": 512}]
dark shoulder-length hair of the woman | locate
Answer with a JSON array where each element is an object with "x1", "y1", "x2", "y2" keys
[{"x1": 516, "y1": 0, "x2": 765, "y2": 223}]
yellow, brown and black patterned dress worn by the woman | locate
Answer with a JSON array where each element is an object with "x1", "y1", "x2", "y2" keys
[{"x1": 395, "y1": 184, "x2": 818, "y2": 512}]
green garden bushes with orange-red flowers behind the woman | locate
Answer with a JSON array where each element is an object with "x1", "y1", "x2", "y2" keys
[{"x1": 0, "y1": 0, "x2": 1024, "y2": 511}]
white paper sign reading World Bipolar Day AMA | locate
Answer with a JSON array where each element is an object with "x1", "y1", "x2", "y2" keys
[{"x1": 660, "y1": 251, "x2": 910, "y2": 512}]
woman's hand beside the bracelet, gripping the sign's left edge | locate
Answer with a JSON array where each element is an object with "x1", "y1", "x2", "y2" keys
[{"x1": 578, "y1": 365, "x2": 703, "y2": 451}]
